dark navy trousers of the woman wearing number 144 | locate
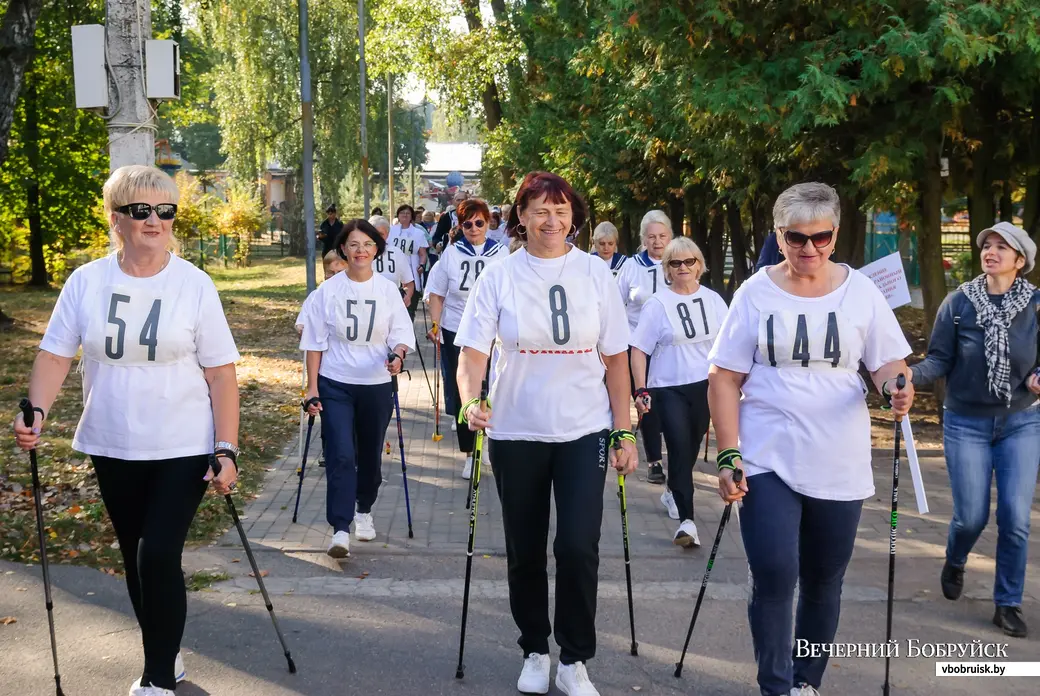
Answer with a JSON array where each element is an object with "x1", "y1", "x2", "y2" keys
[{"x1": 740, "y1": 471, "x2": 863, "y2": 696}]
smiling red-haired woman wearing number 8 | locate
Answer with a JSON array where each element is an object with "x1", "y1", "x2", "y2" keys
[{"x1": 456, "y1": 172, "x2": 638, "y2": 696}]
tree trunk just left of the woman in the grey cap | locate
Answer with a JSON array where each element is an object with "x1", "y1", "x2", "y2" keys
[{"x1": 917, "y1": 133, "x2": 946, "y2": 336}]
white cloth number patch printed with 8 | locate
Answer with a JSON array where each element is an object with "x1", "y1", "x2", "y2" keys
[{"x1": 514, "y1": 279, "x2": 599, "y2": 353}]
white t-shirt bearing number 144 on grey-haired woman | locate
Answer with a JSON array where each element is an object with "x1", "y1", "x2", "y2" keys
[{"x1": 708, "y1": 265, "x2": 911, "y2": 500}]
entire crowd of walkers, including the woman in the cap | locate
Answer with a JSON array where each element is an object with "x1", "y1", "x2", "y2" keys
[{"x1": 15, "y1": 166, "x2": 1040, "y2": 696}]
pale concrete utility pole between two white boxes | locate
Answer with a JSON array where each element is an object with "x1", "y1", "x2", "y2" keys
[{"x1": 105, "y1": 0, "x2": 157, "y2": 172}]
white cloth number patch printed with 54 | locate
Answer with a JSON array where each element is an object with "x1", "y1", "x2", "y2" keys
[{"x1": 95, "y1": 288, "x2": 172, "y2": 365}]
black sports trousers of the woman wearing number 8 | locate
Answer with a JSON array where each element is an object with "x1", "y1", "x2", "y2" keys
[{"x1": 490, "y1": 431, "x2": 607, "y2": 665}]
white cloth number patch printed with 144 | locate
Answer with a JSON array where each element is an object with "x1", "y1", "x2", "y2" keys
[{"x1": 758, "y1": 311, "x2": 851, "y2": 369}]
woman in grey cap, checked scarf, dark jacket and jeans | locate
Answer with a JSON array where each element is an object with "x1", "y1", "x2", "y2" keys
[{"x1": 911, "y1": 222, "x2": 1040, "y2": 638}]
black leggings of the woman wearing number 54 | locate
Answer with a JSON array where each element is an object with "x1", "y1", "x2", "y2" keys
[{"x1": 90, "y1": 455, "x2": 209, "y2": 690}]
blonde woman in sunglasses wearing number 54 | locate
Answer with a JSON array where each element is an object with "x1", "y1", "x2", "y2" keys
[{"x1": 15, "y1": 165, "x2": 239, "y2": 696}]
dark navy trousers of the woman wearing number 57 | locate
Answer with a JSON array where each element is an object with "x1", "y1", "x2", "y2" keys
[{"x1": 318, "y1": 376, "x2": 393, "y2": 532}]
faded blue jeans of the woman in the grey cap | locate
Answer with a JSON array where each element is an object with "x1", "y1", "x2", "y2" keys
[{"x1": 942, "y1": 405, "x2": 1040, "y2": 607}]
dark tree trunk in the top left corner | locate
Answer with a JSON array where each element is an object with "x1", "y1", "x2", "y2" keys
[{"x1": 0, "y1": 0, "x2": 44, "y2": 164}]
